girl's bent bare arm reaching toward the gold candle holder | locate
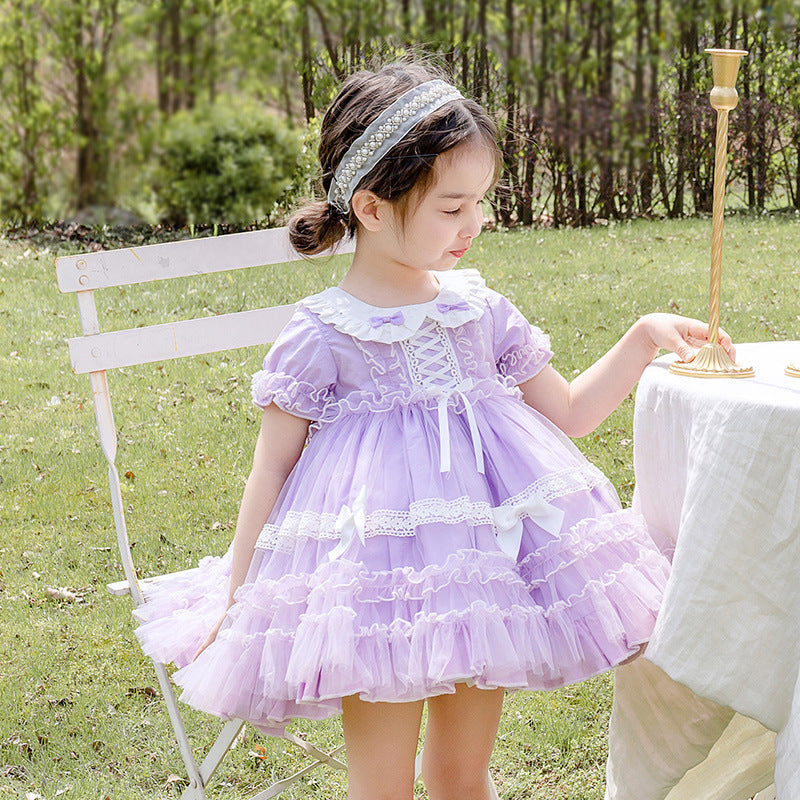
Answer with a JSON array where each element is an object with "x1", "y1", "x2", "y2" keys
[{"x1": 519, "y1": 314, "x2": 734, "y2": 437}]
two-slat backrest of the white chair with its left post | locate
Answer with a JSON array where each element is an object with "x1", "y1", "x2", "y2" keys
[{"x1": 56, "y1": 223, "x2": 354, "y2": 605}]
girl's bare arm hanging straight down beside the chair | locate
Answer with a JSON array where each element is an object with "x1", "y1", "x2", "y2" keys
[{"x1": 195, "y1": 404, "x2": 309, "y2": 658}]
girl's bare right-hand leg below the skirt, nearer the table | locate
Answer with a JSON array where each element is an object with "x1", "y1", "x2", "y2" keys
[{"x1": 422, "y1": 683, "x2": 505, "y2": 800}]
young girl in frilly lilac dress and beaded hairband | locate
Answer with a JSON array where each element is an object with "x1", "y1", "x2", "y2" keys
[{"x1": 137, "y1": 64, "x2": 730, "y2": 800}]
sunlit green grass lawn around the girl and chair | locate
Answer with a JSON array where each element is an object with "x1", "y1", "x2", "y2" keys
[{"x1": 0, "y1": 216, "x2": 800, "y2": 800}]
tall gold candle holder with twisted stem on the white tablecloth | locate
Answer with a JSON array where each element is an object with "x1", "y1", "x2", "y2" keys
[{"x1": 670, "y1": 49, "x2": 755, "y2": 378}]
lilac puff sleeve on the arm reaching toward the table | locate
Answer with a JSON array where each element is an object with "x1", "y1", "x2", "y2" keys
[{"x1": 490, "y1": 292, "x2": 553, "y2": 384}]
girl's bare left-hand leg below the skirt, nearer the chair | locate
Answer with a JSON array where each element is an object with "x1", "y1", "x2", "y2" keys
[{"x1": 342, "y1": 695, "x2": 422, "y2": 800}]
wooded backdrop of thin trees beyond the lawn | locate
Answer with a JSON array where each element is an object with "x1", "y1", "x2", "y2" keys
[{"x1": 0, "y1": 0, "x2": 800, "y2": 225}]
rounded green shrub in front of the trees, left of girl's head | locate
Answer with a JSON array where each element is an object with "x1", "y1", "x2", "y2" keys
[{"x1": 154, "y1": 104, "x2": 300, "y2": 225}]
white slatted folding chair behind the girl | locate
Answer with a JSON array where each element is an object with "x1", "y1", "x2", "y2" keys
[{"x1": 56, "y1": 223, "x2": 497, "y2": 800}]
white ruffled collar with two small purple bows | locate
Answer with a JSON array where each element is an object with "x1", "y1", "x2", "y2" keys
[{"x1": 300, "y1": 269, "x2": 486, "y2": 344}]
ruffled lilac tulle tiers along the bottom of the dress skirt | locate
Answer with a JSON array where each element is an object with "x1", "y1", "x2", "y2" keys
[{"x1": 139, "y1": 511, "x2": 667, "y2": 732}]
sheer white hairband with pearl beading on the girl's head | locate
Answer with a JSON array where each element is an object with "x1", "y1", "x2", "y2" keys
[{"x1": 328, "y1": 80, "x2": 463, "y2": 214}]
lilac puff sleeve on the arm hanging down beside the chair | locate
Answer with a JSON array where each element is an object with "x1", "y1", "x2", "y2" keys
[{"x1": 250, "y1": 308, "x2": 336, "y2": 421}]
